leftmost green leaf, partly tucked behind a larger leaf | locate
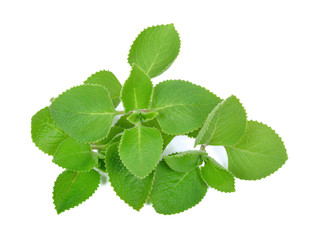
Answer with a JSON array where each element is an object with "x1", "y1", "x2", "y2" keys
[{"x1": 31, "y1": 107, "x2": 68, "y2": 155}]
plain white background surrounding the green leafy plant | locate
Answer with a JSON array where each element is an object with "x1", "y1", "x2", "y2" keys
[{"x1": 0, "y1": 0, "x2": 320, "y2": 239}]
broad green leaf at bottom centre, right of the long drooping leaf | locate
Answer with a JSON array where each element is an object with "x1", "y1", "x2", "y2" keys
[{"x1": 150, "y1": 161, "x2": 207, "y2": 214}]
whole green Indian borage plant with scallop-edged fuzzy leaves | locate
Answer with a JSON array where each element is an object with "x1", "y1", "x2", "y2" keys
[{"x1": 32, "y1": 24, "x2": 287, "y2": 214}]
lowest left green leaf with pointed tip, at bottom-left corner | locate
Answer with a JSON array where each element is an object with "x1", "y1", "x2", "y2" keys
[{"x1": 53, "y1": 170, "x2": 100, "y2": 214}]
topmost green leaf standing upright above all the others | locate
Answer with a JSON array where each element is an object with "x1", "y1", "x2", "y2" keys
[{"x1": 128, "y1": 24, "x2": 180, "y2": 78}]
